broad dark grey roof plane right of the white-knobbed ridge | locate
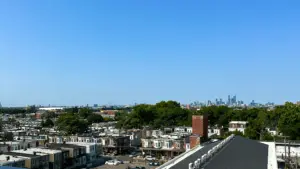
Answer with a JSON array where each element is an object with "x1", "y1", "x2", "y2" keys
[{"x1": 205, "y1": 136, "x2": 268, "y2": 169}]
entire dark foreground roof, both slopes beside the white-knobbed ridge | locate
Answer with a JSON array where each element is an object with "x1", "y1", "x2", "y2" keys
[{"x1": 170, "y1": 136, "x2": 268, "y2": 169}]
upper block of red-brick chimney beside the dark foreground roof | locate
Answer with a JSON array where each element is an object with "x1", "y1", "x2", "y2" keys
[{"x1": 192, "y1": 115, "x2": 208, "y2": 138}]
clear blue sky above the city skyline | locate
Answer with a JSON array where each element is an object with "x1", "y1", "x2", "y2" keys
[{"x1": 0, "y1": 0, "x2": 300, "y2": 106}]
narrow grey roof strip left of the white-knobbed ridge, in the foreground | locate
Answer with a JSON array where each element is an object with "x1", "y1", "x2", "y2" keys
[{"x1": 170, "y1": 141, "x2": 219, "y2": 169}]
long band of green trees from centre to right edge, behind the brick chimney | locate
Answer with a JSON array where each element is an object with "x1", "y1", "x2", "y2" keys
[{"x1": 116, "y1": 101, "x2": 300, "y2": 140}]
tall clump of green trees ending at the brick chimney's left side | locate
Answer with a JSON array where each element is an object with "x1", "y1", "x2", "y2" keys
[{"x1": 116, "y1": 101, "x2": 192, "y2": 129}]
